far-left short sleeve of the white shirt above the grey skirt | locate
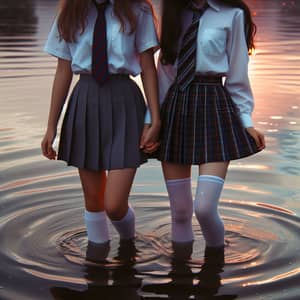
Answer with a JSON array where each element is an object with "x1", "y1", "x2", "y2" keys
[{"x1": 44, "y1": 18, "x2": 72, "y2": 60}]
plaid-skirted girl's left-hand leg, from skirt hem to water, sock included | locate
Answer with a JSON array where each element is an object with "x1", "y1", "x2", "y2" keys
[{"x1": 162, "y1": 162, "x2": 194, "y2": 243}]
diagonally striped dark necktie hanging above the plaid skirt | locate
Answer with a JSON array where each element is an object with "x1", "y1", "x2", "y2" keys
[{"x1": 177, "y1": 3, "x2": 208, "y2": 91}]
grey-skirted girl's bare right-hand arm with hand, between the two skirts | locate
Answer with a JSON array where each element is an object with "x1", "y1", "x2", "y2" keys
[{"x1": 140, "y1": 49, "x2": 161, "y2": 153}]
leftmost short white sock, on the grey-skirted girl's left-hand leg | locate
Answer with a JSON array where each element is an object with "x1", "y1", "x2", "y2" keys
[{"x1": 84, "y1": 210, "x2": 109, "y2": 244}]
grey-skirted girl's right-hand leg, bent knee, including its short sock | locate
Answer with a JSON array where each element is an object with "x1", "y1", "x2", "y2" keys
[{"x1": 105, "y1": 169, "x2": 136, "y2": 239}]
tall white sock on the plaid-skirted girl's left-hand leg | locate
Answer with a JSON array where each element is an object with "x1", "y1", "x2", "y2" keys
[{"x1": 166, "y1": 178, "x2": 194, "y2": 242}]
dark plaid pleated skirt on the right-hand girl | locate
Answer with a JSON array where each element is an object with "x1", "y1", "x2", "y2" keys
[{"x1": 157, "y1": 76, "x2": 259, "y2": 165}]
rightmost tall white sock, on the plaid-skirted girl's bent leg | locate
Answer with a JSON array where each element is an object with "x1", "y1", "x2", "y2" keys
[{"x1": 194, "y1": 175, "x2": 224, "y2": 247}]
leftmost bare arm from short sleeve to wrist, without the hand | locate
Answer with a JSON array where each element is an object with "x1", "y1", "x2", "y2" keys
[{"x1": 48, "y1": 59, "x2": 73, "y2": 129}]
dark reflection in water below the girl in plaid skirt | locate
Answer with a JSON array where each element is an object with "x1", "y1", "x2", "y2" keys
[{"x1": 142, "y1": 243, "x2": 232, "y2": 299}]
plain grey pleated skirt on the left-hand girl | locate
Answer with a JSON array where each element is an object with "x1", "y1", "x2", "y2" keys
[{"x1": 58, "y1": 74, "x2": 146, "y2": 171}]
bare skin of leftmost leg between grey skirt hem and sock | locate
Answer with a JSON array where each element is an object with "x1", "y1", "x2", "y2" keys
[{"x1": 78, "y1": 169, "x2": 106, "y2": 212}]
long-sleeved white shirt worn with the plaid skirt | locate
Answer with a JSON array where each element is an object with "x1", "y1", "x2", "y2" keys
[{"x1": 146, "y1": 0, "x2": 254, "y2": 127}]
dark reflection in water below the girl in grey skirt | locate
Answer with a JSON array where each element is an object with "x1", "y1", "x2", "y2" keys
[{"x1": 51, "y1": 241, "x2": 142, "y2": 300}]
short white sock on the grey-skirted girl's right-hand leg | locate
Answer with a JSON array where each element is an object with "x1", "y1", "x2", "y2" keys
[{"x1": 111, "y1": 206, "x2": 135, "y2": 240}]
